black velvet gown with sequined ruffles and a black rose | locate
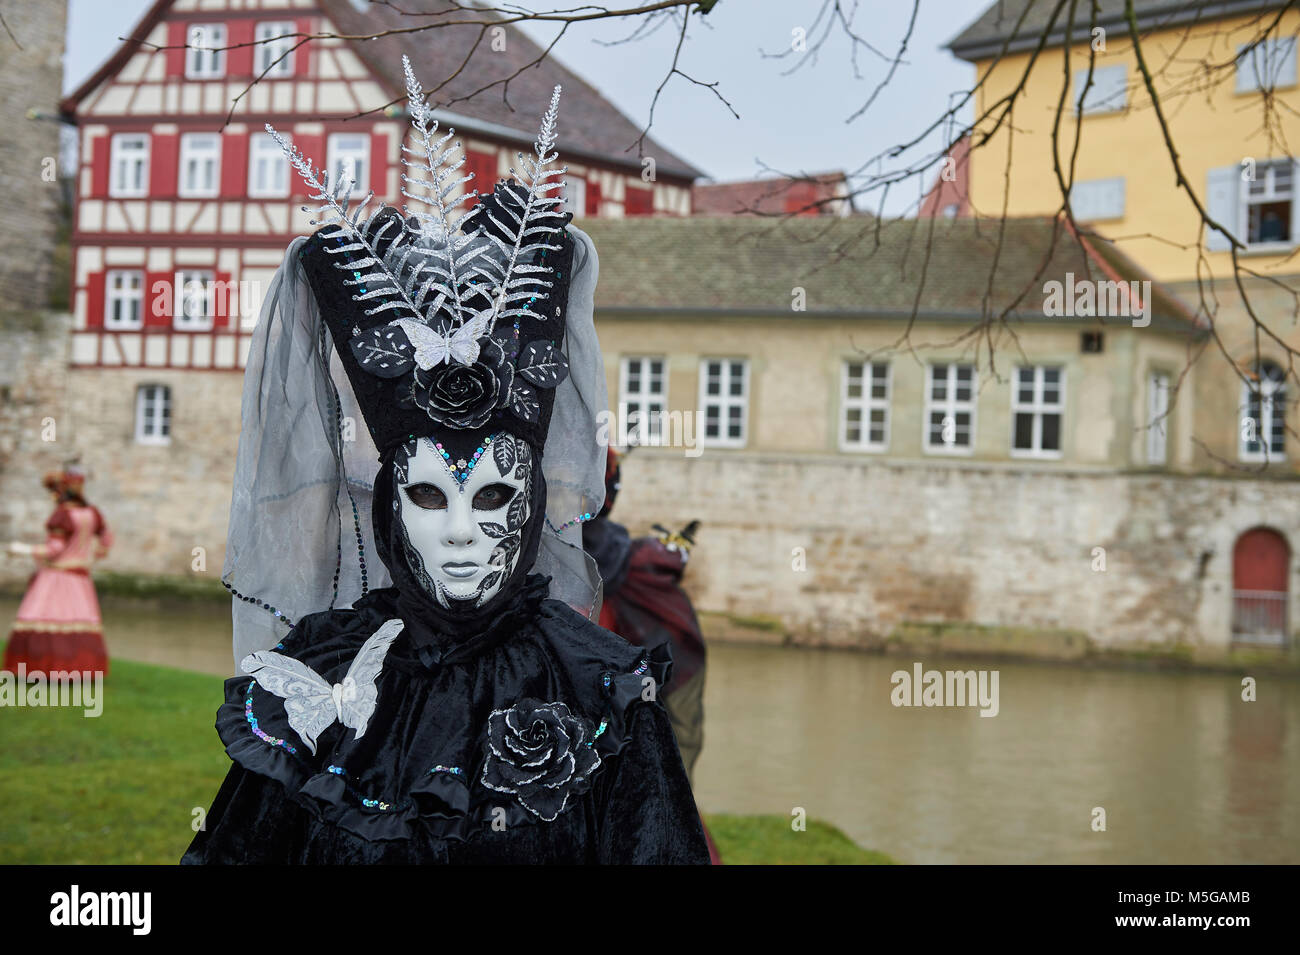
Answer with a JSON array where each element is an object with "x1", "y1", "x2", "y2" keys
[{"x1": 182, "y1": 574, "x2": 709, "y2": 864}]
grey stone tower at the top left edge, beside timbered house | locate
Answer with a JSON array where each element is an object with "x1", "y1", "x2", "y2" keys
[{"x1": 0, "y1": 0, "x2": 68, "y2": 312}]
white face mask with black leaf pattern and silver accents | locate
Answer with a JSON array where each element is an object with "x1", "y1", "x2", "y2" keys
[{"x1": 395, "y1": 431, "x2": 533, "y2": 607}]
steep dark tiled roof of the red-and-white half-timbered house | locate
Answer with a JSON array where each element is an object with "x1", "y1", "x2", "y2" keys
[{"x1": 320, "y1": 0, "x2": 703, "y2": 179}]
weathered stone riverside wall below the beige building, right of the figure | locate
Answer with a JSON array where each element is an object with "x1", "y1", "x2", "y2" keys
[{"x1": 615, "y1": 448, "x2": 1300, "y2": 647}]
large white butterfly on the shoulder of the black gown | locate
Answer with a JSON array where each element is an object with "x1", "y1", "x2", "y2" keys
[{"x1": 239, "y1": 620, "x2": 403, "y2": 755}]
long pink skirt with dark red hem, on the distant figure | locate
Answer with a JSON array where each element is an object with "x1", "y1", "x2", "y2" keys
[{"x1": 4, "y1": 567, "x2": 108, "y2": 673}]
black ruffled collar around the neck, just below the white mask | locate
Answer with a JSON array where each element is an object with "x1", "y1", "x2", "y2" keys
[{"x1": 354, "y1": 574, "x2": 551, "y2": 669}]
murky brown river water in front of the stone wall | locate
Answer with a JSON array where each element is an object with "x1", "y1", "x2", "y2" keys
[{"x1": 0, "y1": 600, "x2": 1300, "y2": 864}]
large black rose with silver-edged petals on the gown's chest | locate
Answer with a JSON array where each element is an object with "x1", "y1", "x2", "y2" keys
[{"x1": 481, "y1": 699, "x2": 601, "y2": 822}]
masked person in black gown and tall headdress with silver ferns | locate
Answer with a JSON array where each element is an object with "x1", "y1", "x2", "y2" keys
[{"x1": 182, "y1": 64, "x2": 709, "y2": 864}]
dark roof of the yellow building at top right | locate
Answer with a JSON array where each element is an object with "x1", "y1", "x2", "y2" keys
[{"x1": 948, "y1": 0, "x2": 1286, "y2": 60}]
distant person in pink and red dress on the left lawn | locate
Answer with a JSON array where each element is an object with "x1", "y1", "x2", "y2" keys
[{"x1": 4, "y1": 468, "x2": 113, "y2": 674}]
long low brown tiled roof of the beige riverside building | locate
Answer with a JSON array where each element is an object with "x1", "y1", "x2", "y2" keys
[{"x1": 575, "y1": 216, "x2": 1195, "y2": 331}]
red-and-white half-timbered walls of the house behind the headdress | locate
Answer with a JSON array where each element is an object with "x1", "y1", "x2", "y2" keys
[{"x1": 64, "y1": 0, "x2": 690, "y2": 370}]
